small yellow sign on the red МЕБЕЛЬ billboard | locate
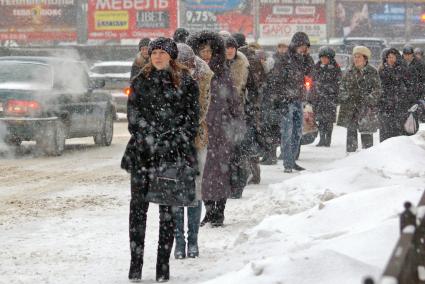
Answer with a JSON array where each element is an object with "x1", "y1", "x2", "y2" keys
[{"x1": 94, "y1": 11, "x2": 129, "y2": 31}]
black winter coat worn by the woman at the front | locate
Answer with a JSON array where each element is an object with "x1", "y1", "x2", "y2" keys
[{"x1": 122, "y1": 69, "x2": 199, "y2": 200}]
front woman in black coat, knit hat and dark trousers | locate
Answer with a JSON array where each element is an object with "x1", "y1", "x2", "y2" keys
[{"x1": 122, "y1": 38, "x2": 199, "y2": 282}]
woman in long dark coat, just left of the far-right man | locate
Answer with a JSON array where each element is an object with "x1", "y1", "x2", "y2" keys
[{"x1": 378, "y1": 48, "x2": 415, "y2": 142}]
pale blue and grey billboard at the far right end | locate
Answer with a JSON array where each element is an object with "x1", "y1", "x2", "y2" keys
[{"x1": 335, "y1": 0, "x2": 425, "y2": 38}]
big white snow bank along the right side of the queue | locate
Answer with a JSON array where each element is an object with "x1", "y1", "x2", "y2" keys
[{"x1": 204, "y1": 137, "x2": 425, "y2": 284}]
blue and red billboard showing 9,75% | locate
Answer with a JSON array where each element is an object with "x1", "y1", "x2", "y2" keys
[{"x1": 180, "y1": 0, "x2": 254, "y2": 36}]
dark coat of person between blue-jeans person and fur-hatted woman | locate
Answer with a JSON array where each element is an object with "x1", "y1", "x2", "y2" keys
[{"x1": 312, "y1": 60, "x2": 342, "y2": 122}]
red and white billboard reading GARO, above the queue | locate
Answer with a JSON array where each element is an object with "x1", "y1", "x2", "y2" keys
[{"x1": 260, "y1": 0, "x2": 326, "y2": 43}]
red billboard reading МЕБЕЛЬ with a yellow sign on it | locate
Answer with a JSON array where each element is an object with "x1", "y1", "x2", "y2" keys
[{"x1": 87, "y1": 0, "x2": 177, "y2": 39}]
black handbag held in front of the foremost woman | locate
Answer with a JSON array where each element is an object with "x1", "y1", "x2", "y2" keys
[{"x1": 146, "y1": 162, "x2": 198, "y2": 207}]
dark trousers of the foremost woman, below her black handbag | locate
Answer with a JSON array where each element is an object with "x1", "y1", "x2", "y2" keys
[{"x1": 129, "y1": 184, "x2": 174, "y2": 272}]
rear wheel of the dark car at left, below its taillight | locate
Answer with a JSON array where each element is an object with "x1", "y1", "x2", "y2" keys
[{"x1": 37, "y1": 121, "x2": 66, "y2": 156}]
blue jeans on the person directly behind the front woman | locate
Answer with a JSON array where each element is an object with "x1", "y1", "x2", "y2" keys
[{"x1": 174, "y1": 201, "x2": 202, "y2": 251}]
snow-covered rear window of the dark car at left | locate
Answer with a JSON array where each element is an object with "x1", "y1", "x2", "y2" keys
[{"x1": 0, "y1": 61, "x2": 53, "y2": 90}]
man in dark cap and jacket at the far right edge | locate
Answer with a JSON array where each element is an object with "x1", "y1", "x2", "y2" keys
[{"x1": 403, "y1": 45, "x2": 425, "y2": 100}]
